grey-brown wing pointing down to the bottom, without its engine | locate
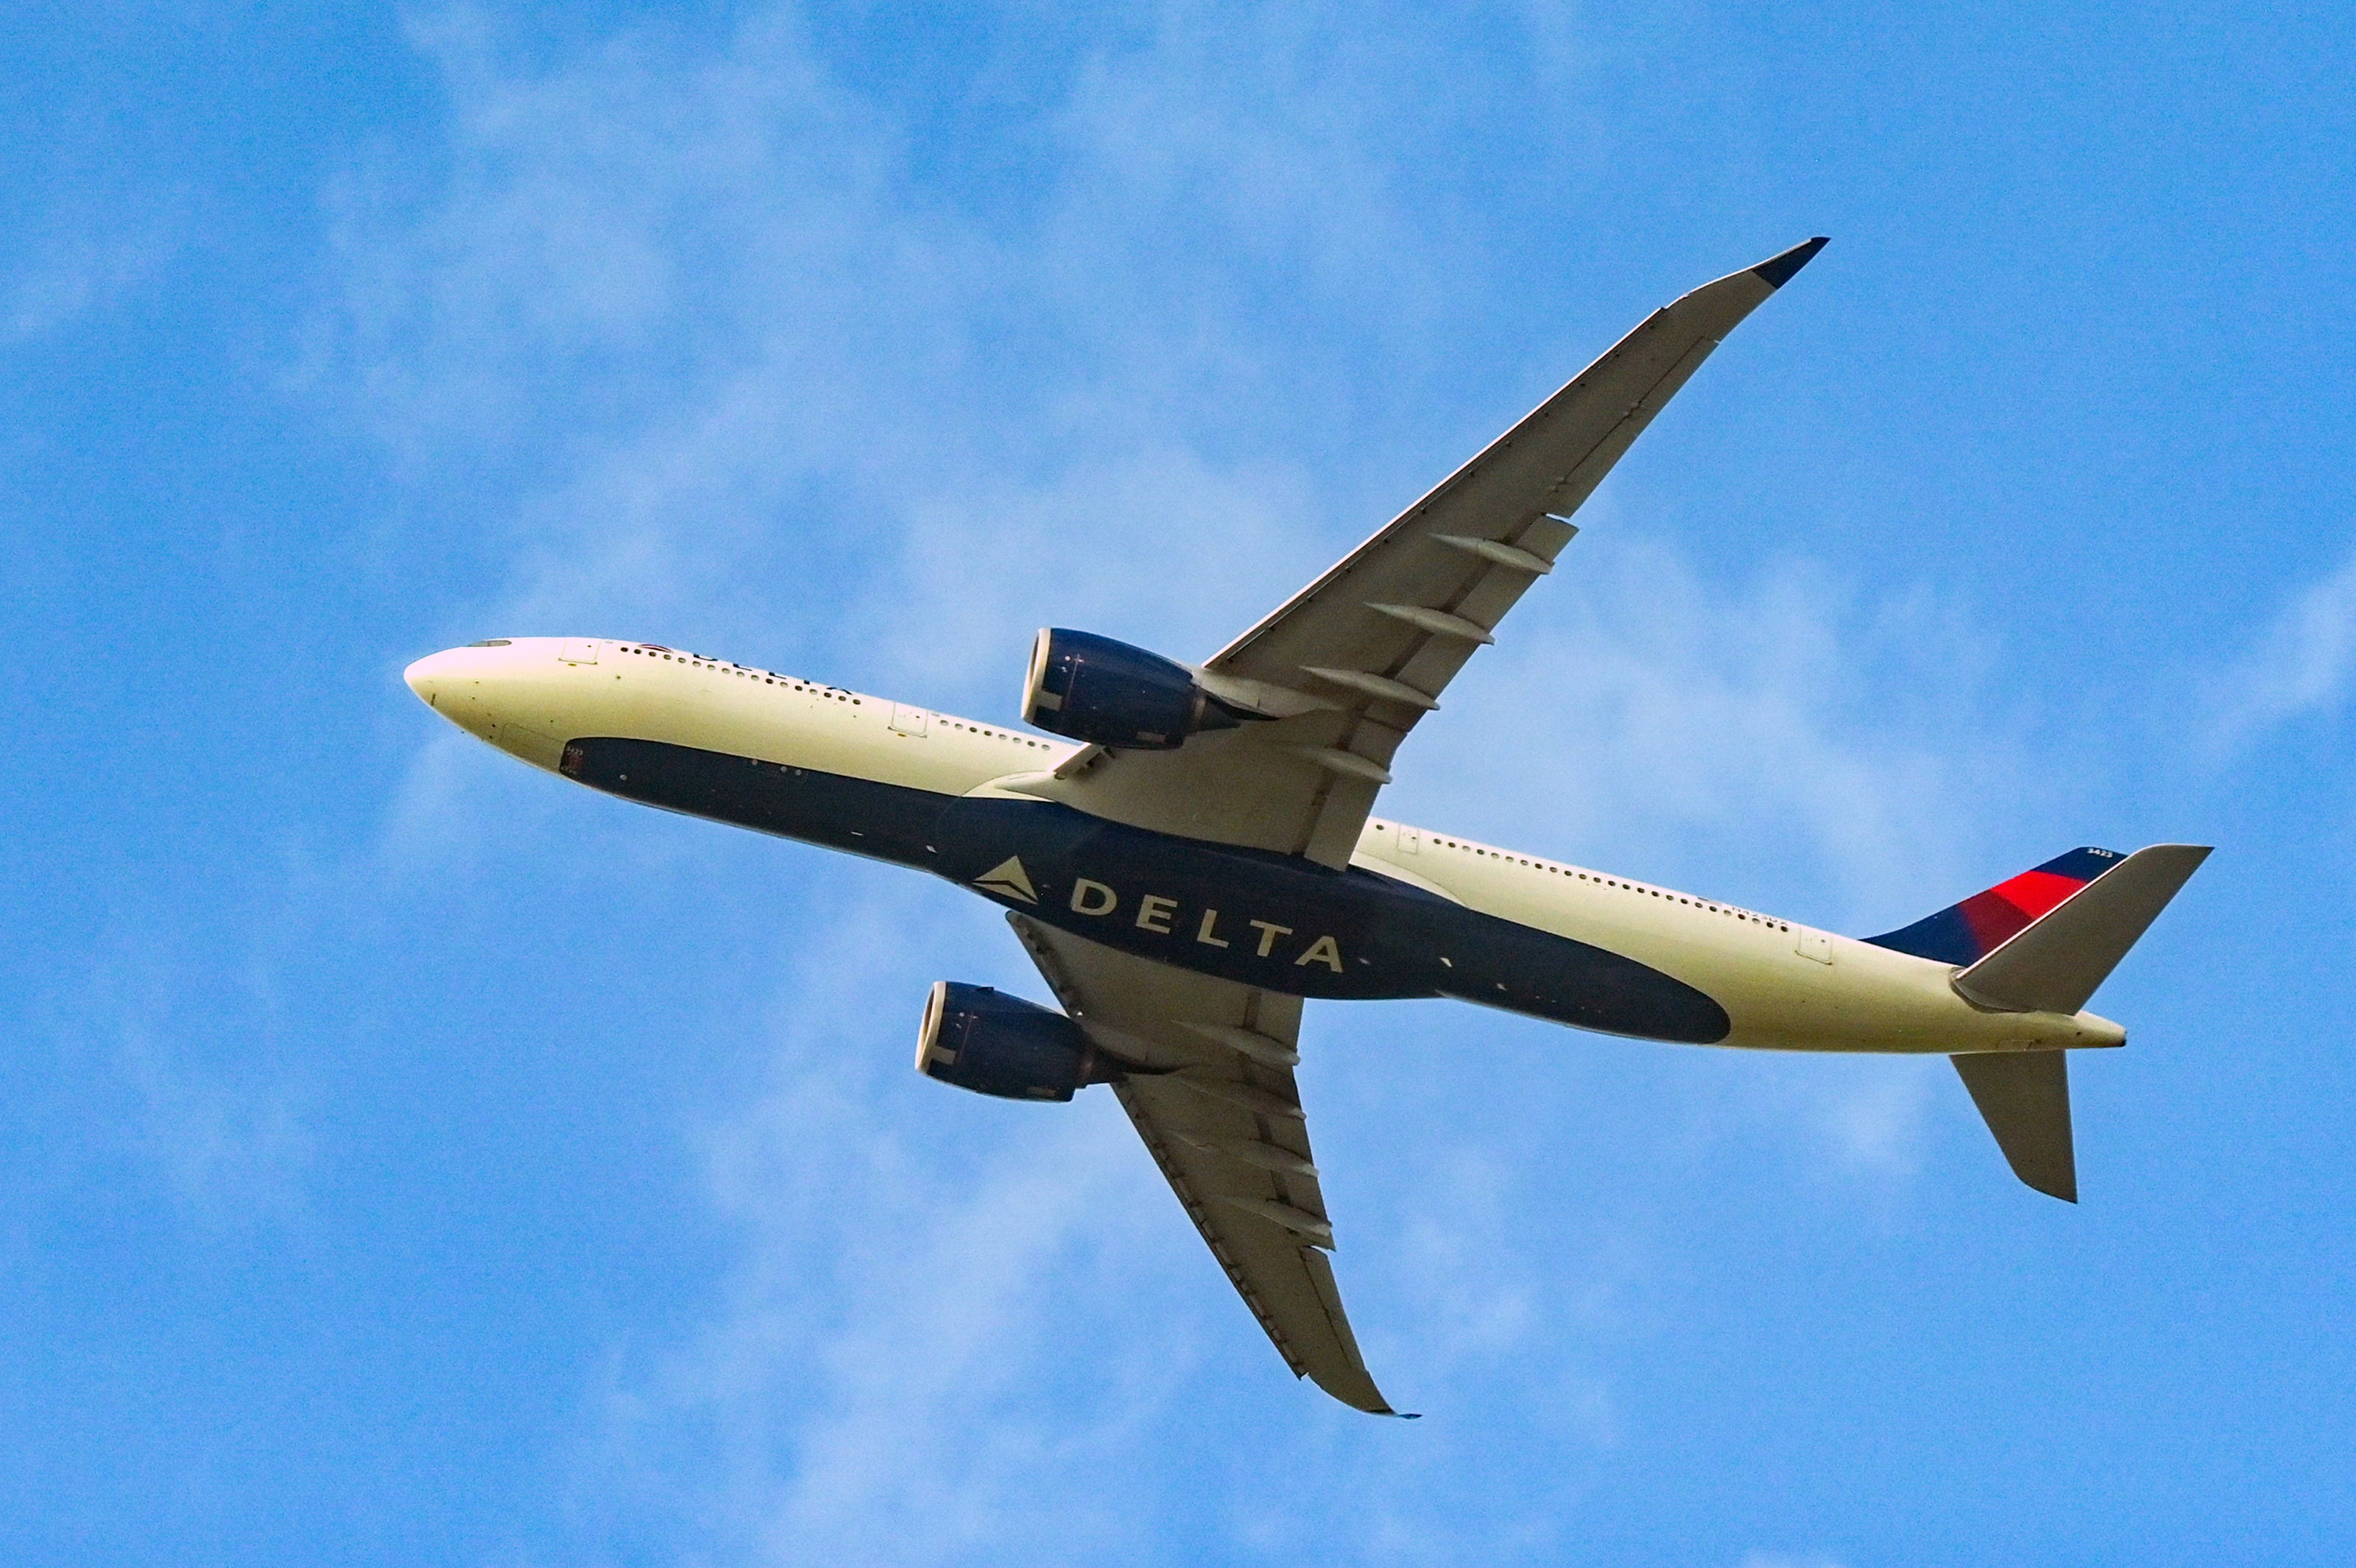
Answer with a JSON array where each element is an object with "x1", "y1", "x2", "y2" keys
[{"x1": 1006, "y1": 914, "x2": 1397, "y2": 1415}]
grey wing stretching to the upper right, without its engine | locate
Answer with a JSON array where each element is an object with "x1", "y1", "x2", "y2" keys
[{"x1": 1041, "y1": 240, "x2": 1824, "y2": 869}]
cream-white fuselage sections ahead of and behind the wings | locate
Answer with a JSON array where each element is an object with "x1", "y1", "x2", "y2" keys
[{"x1": 408, "y1": 638, "x2": 2125, "y2": 1053}]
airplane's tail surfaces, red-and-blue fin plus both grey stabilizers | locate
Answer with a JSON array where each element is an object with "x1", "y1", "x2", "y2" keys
[{"x1": 1869, "y1": 843, "x2": 2210, "y2": 1203}]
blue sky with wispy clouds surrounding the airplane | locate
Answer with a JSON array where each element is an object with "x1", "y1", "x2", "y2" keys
[{"x1": 0, "y1": 0, "x2": 2356, "y2": 1568}]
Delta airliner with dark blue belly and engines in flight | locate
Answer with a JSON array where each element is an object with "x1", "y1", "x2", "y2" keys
[{"x1": 405, "y1": 238, "x2": 2210, "y2": 1415}]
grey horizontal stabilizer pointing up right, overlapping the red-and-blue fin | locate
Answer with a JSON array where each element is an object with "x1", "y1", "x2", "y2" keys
[{"x1": 1953, "y1": 843, "x2": 2210, "y2": 1012}]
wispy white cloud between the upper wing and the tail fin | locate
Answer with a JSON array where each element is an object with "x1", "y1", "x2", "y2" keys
[{"x1": 1392, "y1": 532, "x2": 2059, "y2": 932}]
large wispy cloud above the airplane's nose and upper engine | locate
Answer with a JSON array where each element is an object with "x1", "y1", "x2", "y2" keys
[{"x1": 308, "y1": 7, "x2": 1564, "y2": 666}]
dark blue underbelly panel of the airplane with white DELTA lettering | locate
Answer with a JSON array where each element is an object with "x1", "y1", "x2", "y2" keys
[{"x1": 563, "y1": 739, "x2": 1727, "y2": 1043}]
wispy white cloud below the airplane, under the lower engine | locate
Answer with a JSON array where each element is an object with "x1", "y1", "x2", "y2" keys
[{"x1": 589, "y1": 897, "x2": 1182, "y2": 1564}]
